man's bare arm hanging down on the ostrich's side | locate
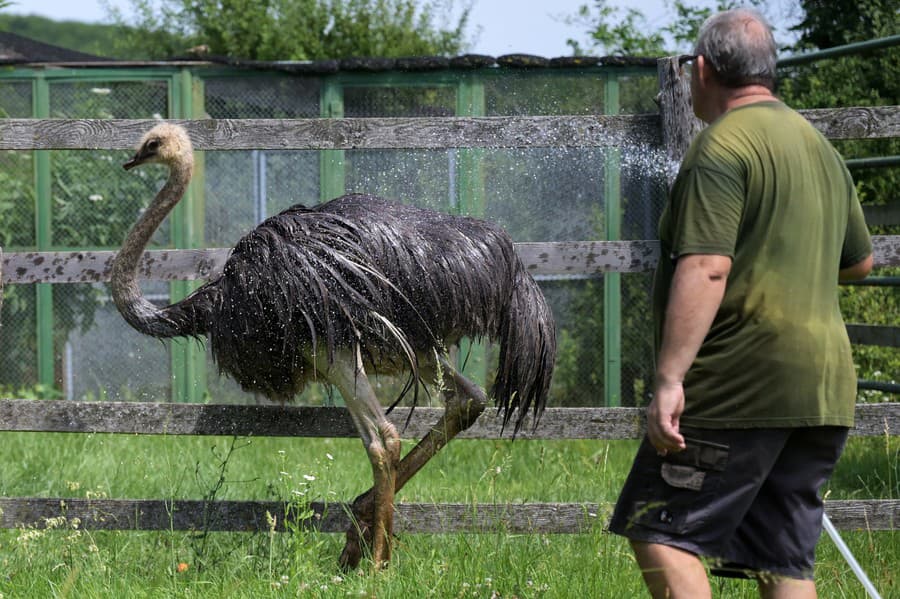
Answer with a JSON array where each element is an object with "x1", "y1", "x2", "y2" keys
[{"x1": 647, "y1": 254, "x2": 731, "y2": 455}]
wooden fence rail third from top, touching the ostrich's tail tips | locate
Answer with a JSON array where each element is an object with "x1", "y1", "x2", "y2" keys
[{"x1": 0, "y1": 399, "x2": 900, "y2": 440}]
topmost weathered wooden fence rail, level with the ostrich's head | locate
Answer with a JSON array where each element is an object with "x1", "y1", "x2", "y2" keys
[{"x1": 0, "y1": 106, "x2": 900, "y2": 150}]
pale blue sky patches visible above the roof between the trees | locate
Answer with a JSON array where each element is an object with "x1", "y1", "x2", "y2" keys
[{"x1": 5, "y1": 0, "x2": 744, "y2": 58}]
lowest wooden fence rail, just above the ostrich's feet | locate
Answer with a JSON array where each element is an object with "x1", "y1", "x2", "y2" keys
[{"x1": 0, "y1": 497, "x2": 900, "y2": 534}]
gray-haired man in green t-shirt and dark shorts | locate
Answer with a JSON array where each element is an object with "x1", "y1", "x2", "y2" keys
[{"x1": 610, "y1": 9, "x2": 872, "y2": 599}]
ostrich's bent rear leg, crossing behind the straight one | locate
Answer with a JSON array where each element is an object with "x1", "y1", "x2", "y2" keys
[{"x1": 340, "y1": 358, "x2": 487, "y2": 570}]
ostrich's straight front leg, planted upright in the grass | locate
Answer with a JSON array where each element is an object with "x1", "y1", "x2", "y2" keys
[{"x1": 328, "y1": 347, "x2": 400, "y2": 569}]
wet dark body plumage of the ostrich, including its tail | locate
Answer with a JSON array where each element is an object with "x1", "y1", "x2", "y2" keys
[{"x1": 164, "y1": 194, "x2": 556, "y2": 430}]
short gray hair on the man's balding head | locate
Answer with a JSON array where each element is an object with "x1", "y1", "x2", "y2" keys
[{"x1": 694, "y1": 8, "x2": 776, "y2": 90}]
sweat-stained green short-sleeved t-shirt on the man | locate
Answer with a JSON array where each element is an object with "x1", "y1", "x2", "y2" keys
[{"x1": 654, "y1": 101, "x2": 872, "y2": 428}]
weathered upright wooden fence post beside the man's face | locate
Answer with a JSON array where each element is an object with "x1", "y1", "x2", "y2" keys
[{"x1": 656, "y1": 56, "x2": 704, "y2": 187}]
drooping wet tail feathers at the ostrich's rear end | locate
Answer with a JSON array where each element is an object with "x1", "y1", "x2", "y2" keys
[{"x1": 491, "y1": 264, "x2": 556, "y2": 435}]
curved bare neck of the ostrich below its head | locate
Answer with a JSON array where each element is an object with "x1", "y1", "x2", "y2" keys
[{"x1": 110, "y1": 158, "x2": 193, "y2": 337}]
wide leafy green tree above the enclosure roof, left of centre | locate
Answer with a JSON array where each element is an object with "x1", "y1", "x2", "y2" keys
[{"x1": 108, "y1": 0, "x2": 471, "y2": 60}]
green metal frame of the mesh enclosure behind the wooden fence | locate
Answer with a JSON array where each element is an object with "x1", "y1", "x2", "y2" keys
[{"x1": 0, "y1": 65, "x2": 656, "y2": 406}]
